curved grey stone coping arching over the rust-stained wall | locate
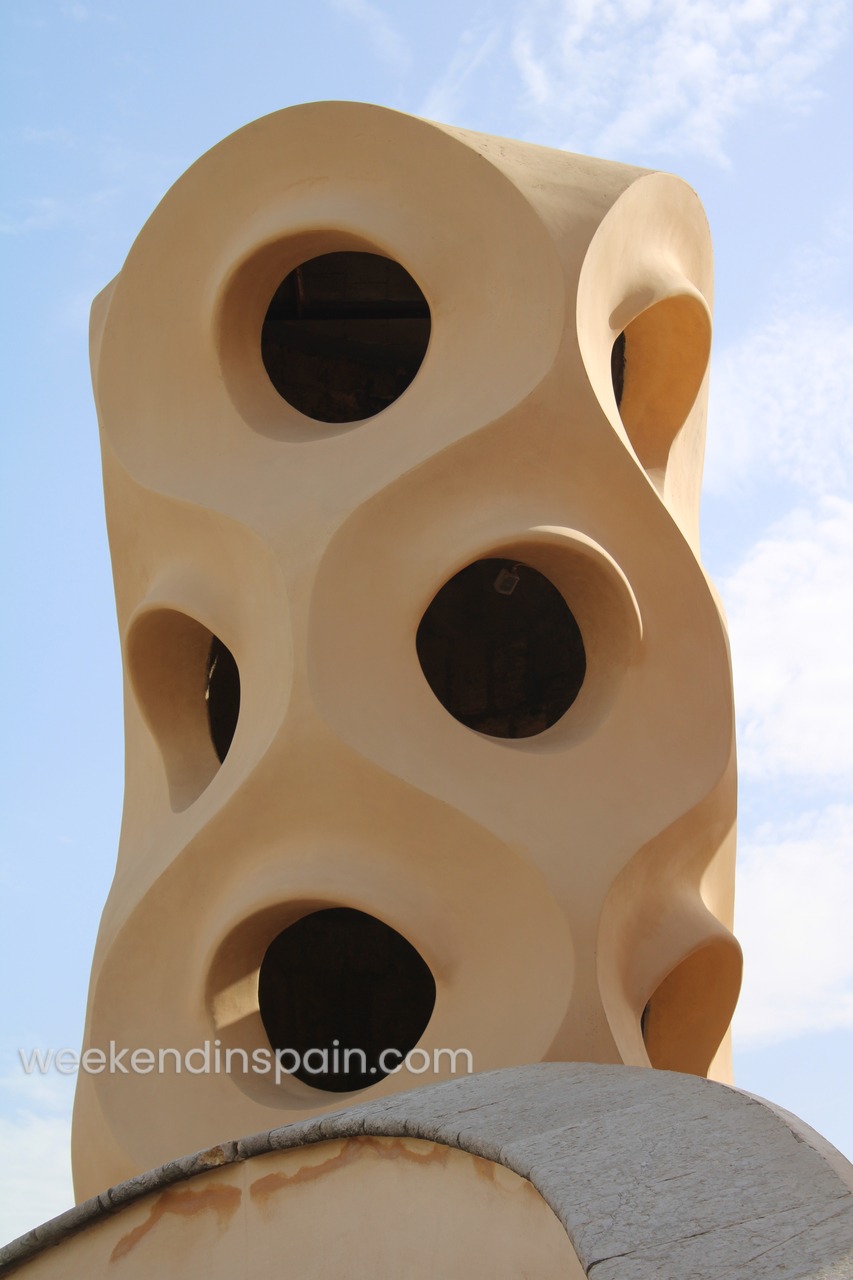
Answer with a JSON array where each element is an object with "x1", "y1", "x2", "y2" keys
[{"x1": 0, "y1": 1062, "x2": 853, "y2": 1280}]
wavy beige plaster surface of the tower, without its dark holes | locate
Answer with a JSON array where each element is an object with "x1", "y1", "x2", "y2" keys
[{"x1": 74, "y1": 104, "x2": 740, "y2": 1196}]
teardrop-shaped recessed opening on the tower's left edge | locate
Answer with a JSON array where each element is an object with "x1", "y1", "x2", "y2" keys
[{"x1": 126, "y1": 607, "x2": 240, "y2": 813}]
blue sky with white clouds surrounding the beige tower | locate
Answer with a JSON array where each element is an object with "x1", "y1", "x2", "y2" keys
[{"x1": 0, "y1": 0, "x2": 853, "y2": 1239}]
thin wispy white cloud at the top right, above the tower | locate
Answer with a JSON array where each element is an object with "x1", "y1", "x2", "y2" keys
[{"x1": 512, "y1": 0, "x2": 847, "y2": 163}]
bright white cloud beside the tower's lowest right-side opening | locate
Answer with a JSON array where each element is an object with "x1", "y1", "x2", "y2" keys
[{"x1": 734, "y1": 805, "x2": 853, "y2": 1048}]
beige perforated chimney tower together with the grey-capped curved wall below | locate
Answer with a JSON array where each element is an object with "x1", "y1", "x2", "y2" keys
[{"x1": 0, "y1": 102, "x2": 853, "y2": 1280}]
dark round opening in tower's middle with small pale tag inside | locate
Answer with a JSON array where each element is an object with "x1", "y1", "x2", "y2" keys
[{"x1": 416, "y1": 559, "x2": 587, "y2": 737}]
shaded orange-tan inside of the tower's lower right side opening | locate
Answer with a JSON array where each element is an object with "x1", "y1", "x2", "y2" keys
[{"x1": 640, "y1": 934, "x2": 743, "y2": 1076}]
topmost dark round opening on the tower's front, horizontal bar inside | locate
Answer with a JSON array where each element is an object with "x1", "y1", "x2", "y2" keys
[{"x1": 261, "y1": 253, "x2": 430, "y2": 422}]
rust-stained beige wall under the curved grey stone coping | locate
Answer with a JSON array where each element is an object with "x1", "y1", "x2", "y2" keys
[{"x1": 19, "y1": 1138, "x2": 585, "y2": 1280}]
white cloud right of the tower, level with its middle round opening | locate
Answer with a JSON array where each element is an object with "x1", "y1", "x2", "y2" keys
[{"x1": 721, "y1": 497, "x2": 853, "y2": 787}]
